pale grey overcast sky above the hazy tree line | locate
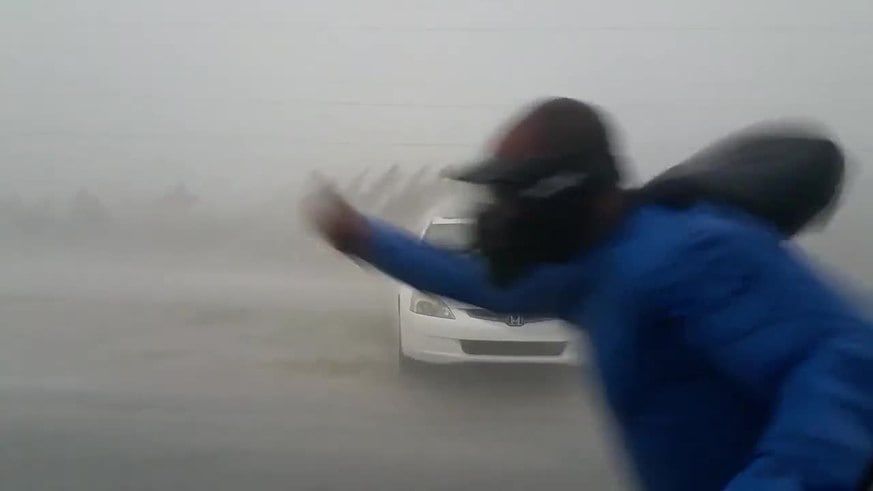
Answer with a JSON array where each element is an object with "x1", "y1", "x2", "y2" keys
[{"x1": 0, "y1": 0, "x2": 873, "y2": 208}]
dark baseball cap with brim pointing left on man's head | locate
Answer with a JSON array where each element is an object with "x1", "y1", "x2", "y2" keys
[{"x1": 445, "y1": 97, "x2": 620, "y2": 188}]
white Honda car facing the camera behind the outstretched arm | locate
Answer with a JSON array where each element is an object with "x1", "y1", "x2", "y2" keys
[{"x1": 396, "y1": 218, "x2": 583, "y2": 370}]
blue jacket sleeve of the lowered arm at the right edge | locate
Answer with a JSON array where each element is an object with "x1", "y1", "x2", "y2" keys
[{"x1": 650, "y1": 224, "x2": 873, "y2": 491}]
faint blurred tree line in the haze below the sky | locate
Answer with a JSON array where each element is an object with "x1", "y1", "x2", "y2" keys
[{"x1": 0, "y1": 165, "x2": 460, "y2": 261}]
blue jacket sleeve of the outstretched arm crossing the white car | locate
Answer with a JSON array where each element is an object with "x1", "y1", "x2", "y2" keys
[{"x1": 360, "y1": 220, "x2": 584, "y2": 314}]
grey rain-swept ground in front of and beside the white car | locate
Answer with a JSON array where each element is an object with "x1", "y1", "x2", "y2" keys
[{"x1": 0, "y1": 261, "x2": 624, "y2": 491}]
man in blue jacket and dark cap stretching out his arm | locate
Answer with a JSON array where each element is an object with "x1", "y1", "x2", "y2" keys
[{"x1": 309, "y1": 99, "x2": 873, "y2": 491}]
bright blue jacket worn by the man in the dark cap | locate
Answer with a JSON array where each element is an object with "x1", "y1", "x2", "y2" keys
[{"x1": 362, "y1": 202, "x2": 873, "y2": 491}]
